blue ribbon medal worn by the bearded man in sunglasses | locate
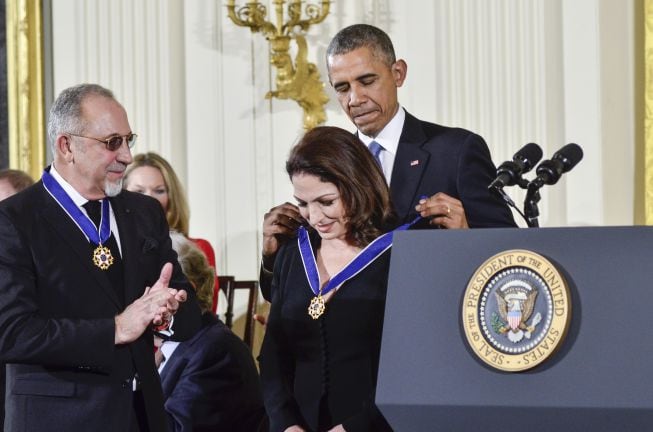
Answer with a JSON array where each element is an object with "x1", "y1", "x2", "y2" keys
[{"x1": 41, "y1": 171, "x2": 114, "y2": 270}]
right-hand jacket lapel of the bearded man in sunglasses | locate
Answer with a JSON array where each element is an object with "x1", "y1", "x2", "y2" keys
[{"x1": 109, "y1": 195, "x2": 144, "y2": 304}]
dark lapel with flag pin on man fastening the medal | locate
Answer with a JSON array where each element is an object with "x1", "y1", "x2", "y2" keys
[{"x1": 390, "y1": 112, "x2": 430, "y2": 222}]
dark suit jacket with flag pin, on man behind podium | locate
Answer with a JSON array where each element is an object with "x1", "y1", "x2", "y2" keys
[{"x1": 390, "y1": 112, "x2": 516, "y2": 228}]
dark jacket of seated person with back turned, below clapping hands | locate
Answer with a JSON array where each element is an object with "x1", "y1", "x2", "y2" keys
[{"x1": 161, "y1": 312, "x2": 267, "y2": 432}]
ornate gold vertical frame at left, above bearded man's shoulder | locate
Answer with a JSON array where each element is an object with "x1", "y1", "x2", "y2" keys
[{"x1": 7, "y1": 0, "x2": 45, "y2": 178}]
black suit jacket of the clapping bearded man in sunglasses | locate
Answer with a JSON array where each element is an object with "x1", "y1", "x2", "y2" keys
[{"x1": 0, "y1": 182, "x2": 200, "y2": 432}]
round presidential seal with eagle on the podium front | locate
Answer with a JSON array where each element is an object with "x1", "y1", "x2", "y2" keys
[{"x1": 462, "y1": 250, "x2": 571, "y2": 372}]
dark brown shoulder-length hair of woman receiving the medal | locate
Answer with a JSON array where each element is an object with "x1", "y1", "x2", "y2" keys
[{"x1": 286, "y1": 126, "x2": 395, "y2": 247}]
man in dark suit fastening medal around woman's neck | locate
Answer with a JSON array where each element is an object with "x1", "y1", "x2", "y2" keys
[{"x1": 261, "y1": 24, "x2": 516, "y2": 299}]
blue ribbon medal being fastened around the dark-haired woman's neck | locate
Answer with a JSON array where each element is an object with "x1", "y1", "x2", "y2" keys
[{"x1": 297, "y1": 217, "x2": 419, "y2": 319}]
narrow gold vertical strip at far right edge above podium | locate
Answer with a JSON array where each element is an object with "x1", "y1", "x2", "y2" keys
[{"x1": 644, "y1": 0, "x2": 653, "y2": 225}]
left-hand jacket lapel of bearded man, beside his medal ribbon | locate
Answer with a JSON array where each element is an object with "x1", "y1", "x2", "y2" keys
[{"x1": 40, "y1": 183, "x2": 122, "y2": 309}]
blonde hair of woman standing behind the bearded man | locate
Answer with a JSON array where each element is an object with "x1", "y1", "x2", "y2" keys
[{"x1": 123, "y1": 152, "x2": 190, "y2": 237}]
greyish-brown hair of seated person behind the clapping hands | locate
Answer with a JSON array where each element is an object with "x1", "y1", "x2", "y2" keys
[{"x1": 170, "y1": 231, "x2": 215, "y2": 313}]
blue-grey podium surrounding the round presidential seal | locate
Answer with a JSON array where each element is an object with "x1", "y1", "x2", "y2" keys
[{"x1": 376, "y1": 227, "x2": 653, "y2": 432}]
